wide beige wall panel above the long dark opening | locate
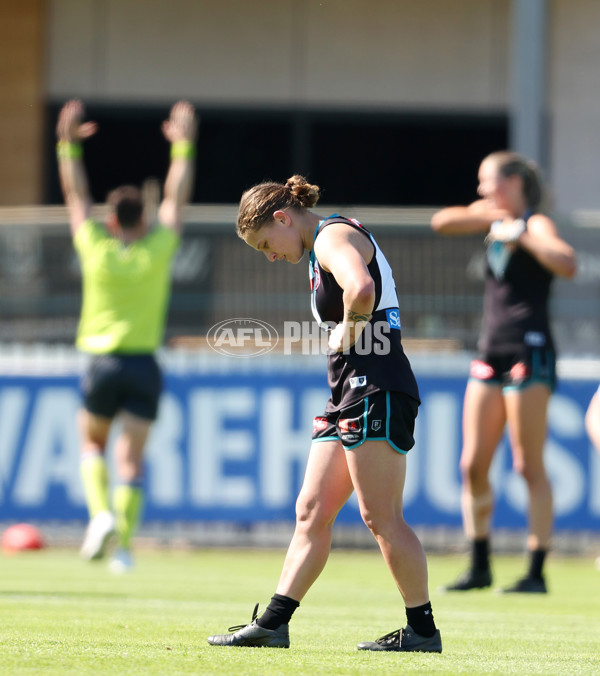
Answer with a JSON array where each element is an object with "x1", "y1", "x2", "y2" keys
[{"x1": 48, "y1": 0, "x2": 509, "y2": 109}]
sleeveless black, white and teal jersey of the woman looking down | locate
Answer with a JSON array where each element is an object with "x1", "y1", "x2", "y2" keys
[{"x1": 309, "y1": 214, "x2": 419, "y2": 412}]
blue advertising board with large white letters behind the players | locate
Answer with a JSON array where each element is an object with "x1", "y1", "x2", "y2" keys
[{"x1": 0, "y1": 358, "x2": 600, "y2": 531}]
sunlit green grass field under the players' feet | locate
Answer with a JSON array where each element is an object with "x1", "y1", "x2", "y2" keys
[{"x1": 0, "y1": 549, "x2": 600, "y2": 676}]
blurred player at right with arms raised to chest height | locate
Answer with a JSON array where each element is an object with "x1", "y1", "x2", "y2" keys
[{"x1": 431, "y1": 152, "x2": 576, "y2": 592}]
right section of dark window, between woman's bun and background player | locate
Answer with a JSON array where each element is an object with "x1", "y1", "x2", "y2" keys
[{"x1": 311, "y1": 114, "x2": 507, "y2": 206}]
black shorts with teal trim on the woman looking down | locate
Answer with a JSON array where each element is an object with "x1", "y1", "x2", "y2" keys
[{"x1": 312, "y1": 392, "x2": 419, "y2": 453}]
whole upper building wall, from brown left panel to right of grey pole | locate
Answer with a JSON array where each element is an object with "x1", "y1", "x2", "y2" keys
[{"x1": 0, "y1": 0, "x2": 600, "y2": 213}]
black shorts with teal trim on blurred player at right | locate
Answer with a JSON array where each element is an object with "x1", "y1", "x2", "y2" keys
[{"x1": 469, "y1": 347, "x2": 556, "y2": 391}]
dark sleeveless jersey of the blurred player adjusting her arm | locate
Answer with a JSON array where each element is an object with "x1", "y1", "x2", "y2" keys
[{"x1": 478, "y1": 213, "x2": 554, "y2": 356}]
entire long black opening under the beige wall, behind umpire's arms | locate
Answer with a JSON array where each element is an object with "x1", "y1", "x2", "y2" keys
[{"x1": 44, "y1": 102, "x2": 508, "y2": 206}]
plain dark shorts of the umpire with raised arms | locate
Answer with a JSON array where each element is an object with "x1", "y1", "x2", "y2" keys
[{"x1": 81, "y1": 354, "x2": 162, "y2": 420}]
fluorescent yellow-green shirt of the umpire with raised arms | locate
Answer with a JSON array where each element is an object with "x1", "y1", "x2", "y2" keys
[{"x1": 74, "y1": 220, "x2": 180, "y2": 354}]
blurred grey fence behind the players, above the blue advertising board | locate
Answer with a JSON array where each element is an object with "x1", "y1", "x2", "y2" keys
[{"x1": 0, "y1": 206, "x2": 600, "y2": 358}]
